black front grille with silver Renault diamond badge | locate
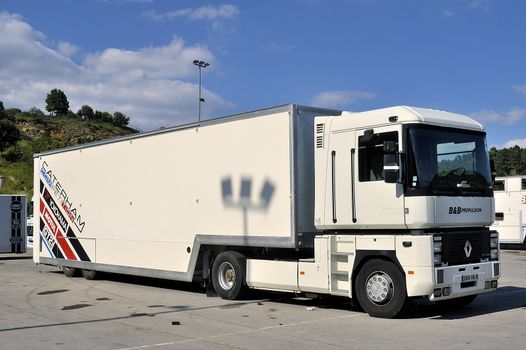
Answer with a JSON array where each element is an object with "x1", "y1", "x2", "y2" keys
[{"x1": 440, "y1": 230, "x2": 490, "y2": 266}]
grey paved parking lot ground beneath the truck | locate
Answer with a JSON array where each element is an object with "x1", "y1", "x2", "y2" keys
[{"x1": 0, "y1": 251, "x2": 526, "y2": 350}]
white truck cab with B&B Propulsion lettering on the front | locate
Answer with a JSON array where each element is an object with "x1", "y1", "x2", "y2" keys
[{"x1": 314, "y1": 106, "x2": 500, "y2": 317}]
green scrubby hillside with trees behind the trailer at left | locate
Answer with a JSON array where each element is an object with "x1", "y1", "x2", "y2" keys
[{"x1": 0, "y1": 90, "x2": 137, "y2": 204}]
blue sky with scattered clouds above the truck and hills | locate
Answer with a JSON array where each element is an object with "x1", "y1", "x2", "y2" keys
[{"x1": 0, "y1": 0, "x2": 526, "y2": 148}]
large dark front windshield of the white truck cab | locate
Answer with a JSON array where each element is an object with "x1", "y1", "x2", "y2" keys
[{"x1": 407, "y1": 125, "x2": 492, "y2": 196}]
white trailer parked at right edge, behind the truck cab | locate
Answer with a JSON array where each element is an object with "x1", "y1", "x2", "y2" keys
[{"x1": 491, "y1": 175, "x2": 526, "y2": 247}]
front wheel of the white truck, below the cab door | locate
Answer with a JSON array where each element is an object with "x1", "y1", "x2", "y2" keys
[{"x1": 354, "y1": 259, "x2": 407, "y2": 318}]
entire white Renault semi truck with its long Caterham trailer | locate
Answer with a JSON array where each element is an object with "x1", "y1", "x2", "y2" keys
[{"x1": 34, "y1": 105, "x2": 500, "y2": 317}]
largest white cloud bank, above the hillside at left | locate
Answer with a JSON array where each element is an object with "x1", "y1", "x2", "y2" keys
[{"x1": 0, "y1": 12, "x2": 229, "y2": 130}]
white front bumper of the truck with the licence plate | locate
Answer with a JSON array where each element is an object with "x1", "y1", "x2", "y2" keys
[{"x1": 429, "y1": 261, "x2": 500, "y2": 300}]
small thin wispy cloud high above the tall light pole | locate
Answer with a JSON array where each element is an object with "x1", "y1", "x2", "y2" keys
[{"x1": 144, "y1": 4, "x2": 239, "y2": 21}]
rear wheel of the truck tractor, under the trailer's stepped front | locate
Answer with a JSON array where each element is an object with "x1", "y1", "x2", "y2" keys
[{"x1": 212, "y1": 251, "x2": 246, "y2": 300}]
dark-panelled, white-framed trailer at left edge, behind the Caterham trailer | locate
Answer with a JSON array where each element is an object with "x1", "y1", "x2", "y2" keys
[{"x1": 0, "y1": 194, "x2": 27, "y2": 253}]
